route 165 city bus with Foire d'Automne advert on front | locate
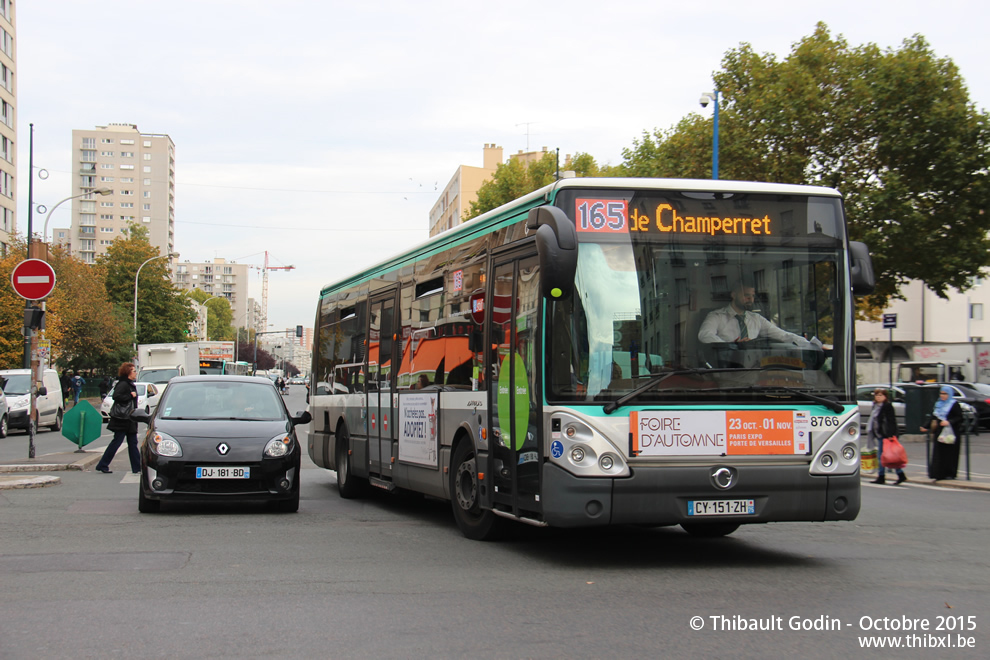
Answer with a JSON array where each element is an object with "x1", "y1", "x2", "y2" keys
[{"x1": 308, "y1": 178, "x2": 874, "y2": 540}]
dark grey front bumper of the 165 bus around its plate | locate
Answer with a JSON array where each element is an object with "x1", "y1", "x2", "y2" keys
[{"x1": 541, "y1": 463, "x2": 860, "y2": 527}]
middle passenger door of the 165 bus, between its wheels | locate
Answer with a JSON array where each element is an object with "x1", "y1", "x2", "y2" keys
[{"x1": 368, "y1": 292, "x2": 398, "y2": 477}]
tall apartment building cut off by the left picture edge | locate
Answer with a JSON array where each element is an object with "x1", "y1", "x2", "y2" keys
[{"x1": 0, "y1": 0, "x2": 14, "y2": 257}]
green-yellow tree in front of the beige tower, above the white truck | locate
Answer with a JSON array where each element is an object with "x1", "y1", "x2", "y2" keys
[{"x1": 97, "y1": 224, "x2": 196, "y2": 344}]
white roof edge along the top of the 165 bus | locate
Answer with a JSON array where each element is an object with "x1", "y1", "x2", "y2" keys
[{"x1": 320, "y1": 177, "x2": 842, "y2": 297}]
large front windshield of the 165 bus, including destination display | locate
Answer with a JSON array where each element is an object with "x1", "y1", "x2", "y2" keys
[{"x1": 545, "y1": 191, "x2": 851, "y2": 404}]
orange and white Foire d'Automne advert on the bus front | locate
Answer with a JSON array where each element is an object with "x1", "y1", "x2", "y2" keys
[{"x1": 629, "y1": 410, "x2": 811, "y2": 456}]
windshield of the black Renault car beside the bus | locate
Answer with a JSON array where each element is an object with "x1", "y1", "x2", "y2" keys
[{"x1": 162, "y1": 380, "x2": 285, "y2": 420}]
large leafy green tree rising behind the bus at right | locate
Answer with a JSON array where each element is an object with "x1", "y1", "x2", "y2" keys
[{"x1": 622, "y1": 23, "x2": 990, "y2": 310}]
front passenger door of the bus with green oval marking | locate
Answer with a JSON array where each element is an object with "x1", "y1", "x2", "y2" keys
[{"x1": 485, "y1": 255, "x2": 543, "y2": 519}]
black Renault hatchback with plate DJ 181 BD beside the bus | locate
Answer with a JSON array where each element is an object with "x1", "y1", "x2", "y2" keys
[{"x1": 133, "y1": 376, "x2": 311, "y2": 513}]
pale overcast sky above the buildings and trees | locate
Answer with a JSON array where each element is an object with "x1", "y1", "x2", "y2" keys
[{"x1": 16, "y1": 0, "x2": 990, "y2": 328}]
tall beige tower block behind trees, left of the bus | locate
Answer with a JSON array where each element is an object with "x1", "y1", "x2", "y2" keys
[{"x1": 69, "y1": 124, "x2": 175, "y2": 263}]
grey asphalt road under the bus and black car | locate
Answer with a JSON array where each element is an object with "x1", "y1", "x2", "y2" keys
[{"x1": 0, "y1": 388, "x2": 990, "y2": 658}]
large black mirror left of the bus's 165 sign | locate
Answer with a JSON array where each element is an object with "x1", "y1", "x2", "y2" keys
[{"x1": 528, "y1": 206, "x2": 577, "y2": 298}]
